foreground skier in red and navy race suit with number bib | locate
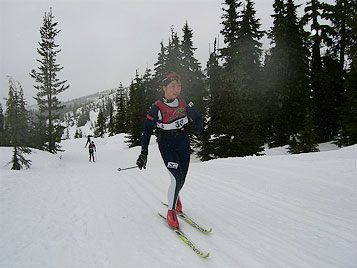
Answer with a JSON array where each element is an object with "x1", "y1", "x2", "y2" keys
[{"x1": 136, "y1": 72, "x2": 203, "y2": 229}]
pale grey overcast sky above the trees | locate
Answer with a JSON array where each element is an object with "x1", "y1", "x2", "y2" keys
[{"x1": 0, "y1": 0, "x2": 333, "y2": 105}]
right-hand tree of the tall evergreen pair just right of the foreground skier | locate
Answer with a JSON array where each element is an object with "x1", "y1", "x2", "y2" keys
[{"x1": 237, "y1": 0, "x2": 265, "y2": 155}]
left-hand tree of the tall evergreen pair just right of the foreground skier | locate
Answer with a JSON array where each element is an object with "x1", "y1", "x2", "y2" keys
[{"x1": 209, "y1": 0, "x2": 242, "y2": 157}]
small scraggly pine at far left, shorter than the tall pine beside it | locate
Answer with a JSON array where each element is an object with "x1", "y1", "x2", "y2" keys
[{"x1": 5, "y1": 78, "x2": 31, "y2": 170}]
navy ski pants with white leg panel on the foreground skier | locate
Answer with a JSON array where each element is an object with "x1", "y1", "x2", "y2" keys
[{"x1": 159, "y1": 135, "x2": 190, "y2": 209}]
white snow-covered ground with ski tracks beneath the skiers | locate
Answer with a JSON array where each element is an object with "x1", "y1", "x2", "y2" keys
[{"x1": 0, "y1": 135, "x2": 357, "y2": 268}]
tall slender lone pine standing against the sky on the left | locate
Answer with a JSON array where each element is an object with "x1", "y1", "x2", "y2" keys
[{"x1": 30, "y1": 10, "x2": 69, "y2": 153}]
